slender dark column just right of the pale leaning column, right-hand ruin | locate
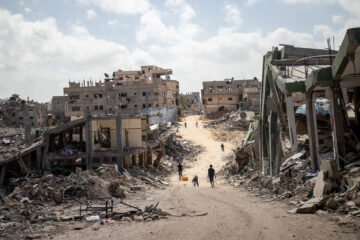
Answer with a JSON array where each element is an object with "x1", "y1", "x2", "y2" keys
[{"x1": 305, "y1": 92, "x2": 319, "y2": 171}]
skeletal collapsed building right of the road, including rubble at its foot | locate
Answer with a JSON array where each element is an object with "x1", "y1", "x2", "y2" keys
[{"x1": 227, "y1": 28, "x2": 360, "y2": 219}]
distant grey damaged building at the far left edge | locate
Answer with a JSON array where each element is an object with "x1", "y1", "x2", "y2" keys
[{"x1": 0, "y1": 94, "x2": 48, "y2": 128}]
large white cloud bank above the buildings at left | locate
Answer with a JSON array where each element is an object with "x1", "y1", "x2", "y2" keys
[{"x1": 0, "y1": 9, "x2": 157, "y2": 101}]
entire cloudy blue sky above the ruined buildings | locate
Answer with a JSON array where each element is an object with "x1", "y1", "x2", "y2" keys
[{"x1": 0, "y1": 0, "x2": 360, "y2": 101}]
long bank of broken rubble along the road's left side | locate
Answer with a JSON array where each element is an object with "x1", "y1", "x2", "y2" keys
[{"x1": 0, "y1": 135, "x2": 202, "y2": 239}]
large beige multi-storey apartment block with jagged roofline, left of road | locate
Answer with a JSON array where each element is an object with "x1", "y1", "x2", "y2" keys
[{"x1": 64, "y1": 65, "x2": 179, "y2": 117}]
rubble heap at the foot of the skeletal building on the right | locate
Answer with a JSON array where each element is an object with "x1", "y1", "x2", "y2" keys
[{"x1": 223, "y1": 151, "x2": 360, "y2": 227}]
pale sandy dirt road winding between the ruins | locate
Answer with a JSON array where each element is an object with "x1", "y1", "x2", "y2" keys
[{"x1": 55, "y1": 117, "x2": 360, "y2": 240}]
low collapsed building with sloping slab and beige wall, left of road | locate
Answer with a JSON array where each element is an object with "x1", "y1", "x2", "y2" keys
[{"x1": 0, "y1": 108, "x2": 179, "y2": 186}]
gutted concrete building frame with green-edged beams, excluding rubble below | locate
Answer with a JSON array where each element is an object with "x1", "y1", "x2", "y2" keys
[{"x1": 254, "y1": 28, "x2": 360, "y2": 175}]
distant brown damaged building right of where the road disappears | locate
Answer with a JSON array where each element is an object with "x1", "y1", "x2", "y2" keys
[{"x1": 201, "y1": 78, "x2": 261, "y2": 114}]
